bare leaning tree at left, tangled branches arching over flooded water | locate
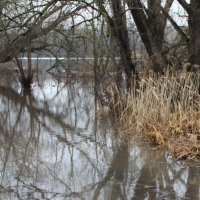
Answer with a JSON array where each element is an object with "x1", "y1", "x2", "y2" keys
[{"x1": 0, "y1": 0, "x2": 86, "y2": 87}]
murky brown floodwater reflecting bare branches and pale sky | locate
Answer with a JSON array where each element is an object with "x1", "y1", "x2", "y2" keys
[{"x1": 0, "y1": 74, "x2": 200, "y2": 200}]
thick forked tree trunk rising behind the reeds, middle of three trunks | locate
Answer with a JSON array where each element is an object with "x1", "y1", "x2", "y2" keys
[{"x1": 126, "y1": 0, "x2": 173, "y2": 73}]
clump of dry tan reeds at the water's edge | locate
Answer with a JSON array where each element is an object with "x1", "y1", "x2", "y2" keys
[{"x1": 109, "y1": 74, "x2": 200, "y2": 159}]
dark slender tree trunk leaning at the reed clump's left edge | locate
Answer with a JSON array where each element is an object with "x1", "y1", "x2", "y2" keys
[{"x1": 95, "y1": 0, "x2": 135, "y2": 89}]
